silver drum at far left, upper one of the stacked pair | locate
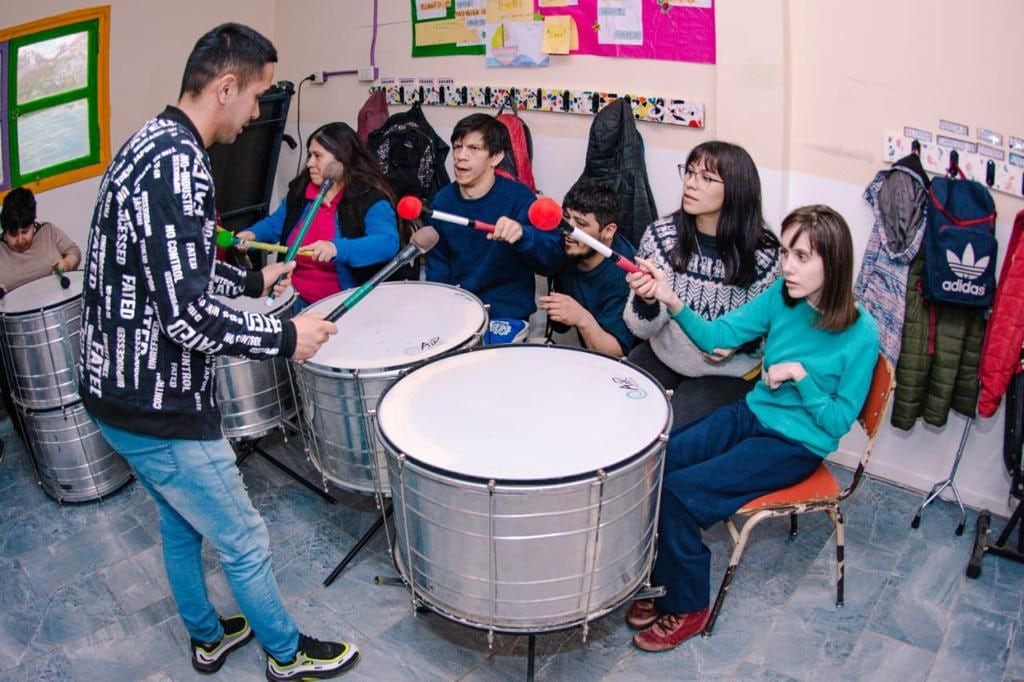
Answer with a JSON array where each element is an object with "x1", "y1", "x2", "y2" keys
[{"x1": 0, "y1": 270, "x2": 82, "y2": 410}]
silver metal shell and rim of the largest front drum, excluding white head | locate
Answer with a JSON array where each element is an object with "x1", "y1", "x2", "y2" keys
[{"x1": 378, "y1": 344, "x2": 672, "y2": 634}]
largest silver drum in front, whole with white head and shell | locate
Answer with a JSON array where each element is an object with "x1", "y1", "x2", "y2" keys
[{"x1": 377, "y1": 345, "x2": 672, "y2": 633}]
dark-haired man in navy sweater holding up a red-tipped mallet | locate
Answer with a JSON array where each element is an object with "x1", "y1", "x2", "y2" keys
[{"x1": 427, "y1": 114, "x2": 564, "y2": 340}]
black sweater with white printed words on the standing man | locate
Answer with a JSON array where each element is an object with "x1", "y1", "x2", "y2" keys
[{"x1": 79, "y1": 106, "x2": 296, "y2": 440}]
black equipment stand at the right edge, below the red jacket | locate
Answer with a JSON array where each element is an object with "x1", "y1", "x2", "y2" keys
[{"x1": 967, "y1": 374, "x2": 1024, "y2": 578}]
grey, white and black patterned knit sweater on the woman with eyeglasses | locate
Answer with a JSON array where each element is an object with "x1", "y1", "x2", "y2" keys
[{"x1": 624, "y1": 216, "x2": 779, "y2": 377}]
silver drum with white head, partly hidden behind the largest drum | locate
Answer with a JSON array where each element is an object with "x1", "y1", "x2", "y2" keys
[{"x1": 296, "y1": 282, "x2": 487, "y2": 494}]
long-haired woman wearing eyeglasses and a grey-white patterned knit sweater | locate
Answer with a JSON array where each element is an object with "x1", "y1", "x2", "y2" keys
[{"x1": 624, "y1": 141, "x2": 778, "y2": 426}]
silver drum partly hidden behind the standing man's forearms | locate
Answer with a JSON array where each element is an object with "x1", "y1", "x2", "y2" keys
[{"x1": 215, "y1": 289, "x2": 296, "y2": 439}]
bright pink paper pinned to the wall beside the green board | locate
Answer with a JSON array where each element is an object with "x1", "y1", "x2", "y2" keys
[{"x1": 538, "y1": 0, "x2": 715, "y2": 63}]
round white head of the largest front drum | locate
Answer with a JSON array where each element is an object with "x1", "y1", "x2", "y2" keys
[{"x1": 377, "y1": 345, "x2": 670, "y2": 481}]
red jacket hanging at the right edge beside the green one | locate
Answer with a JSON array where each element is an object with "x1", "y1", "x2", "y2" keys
[{"x1": 978, "y1": 211, "x2": 1024, "y2": 417}]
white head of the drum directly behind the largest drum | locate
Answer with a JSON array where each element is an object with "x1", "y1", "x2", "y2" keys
[{"x1": 302, "y1": 282, "x2": 486, "y2": 370}]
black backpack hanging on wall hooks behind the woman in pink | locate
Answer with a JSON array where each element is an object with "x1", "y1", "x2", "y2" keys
[{"x1": 367, "y1": 102, "x2": 450, "y2": 202}]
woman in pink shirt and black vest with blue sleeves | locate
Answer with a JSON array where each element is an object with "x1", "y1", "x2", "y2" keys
[{"x1": 237, "y1": 123, "x2": 398, "y2": 307}]
